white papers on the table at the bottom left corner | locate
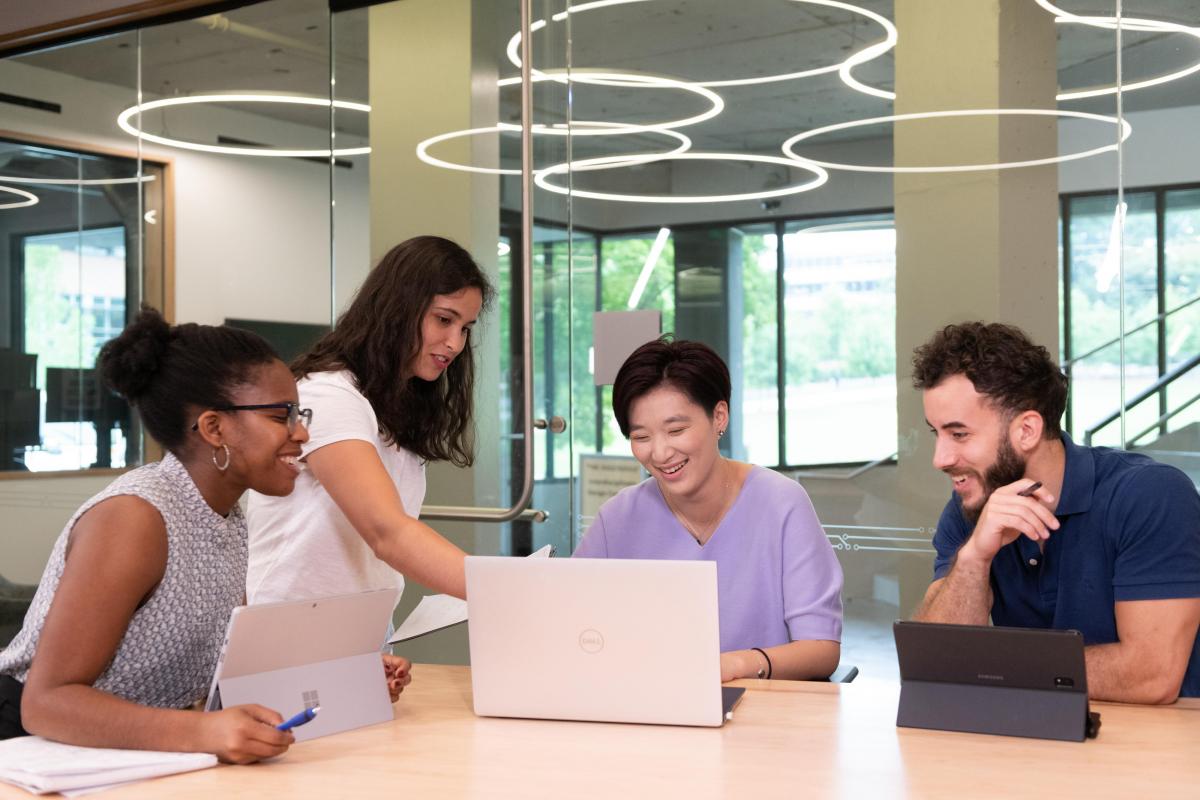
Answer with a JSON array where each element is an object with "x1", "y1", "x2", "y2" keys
[{"x1": 0, "y1": 736, "x2": 217, "y2": 796}]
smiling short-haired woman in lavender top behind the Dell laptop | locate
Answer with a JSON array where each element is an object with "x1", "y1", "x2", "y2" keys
[{"x1": 575, "y1": 338, "x2": 841, "y2": 680}]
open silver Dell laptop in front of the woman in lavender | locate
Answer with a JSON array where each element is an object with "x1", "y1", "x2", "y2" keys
[{"x1": 467, "y1": 557, "x2": 743, "y2": 727}]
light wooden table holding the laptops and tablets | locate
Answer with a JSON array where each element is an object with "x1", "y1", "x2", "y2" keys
[{"x1": 0, "y1": 664, "x2": 1200, "y2": 800}]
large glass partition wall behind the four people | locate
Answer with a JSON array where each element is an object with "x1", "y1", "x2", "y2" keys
[{"x1": 0, "y1": 0, "x2": 1200, "y2": 679}]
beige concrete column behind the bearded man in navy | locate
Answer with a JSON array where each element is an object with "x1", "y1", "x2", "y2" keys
[{"x1": 894, "y1": 0, "x2": 1058, "y2": 607}]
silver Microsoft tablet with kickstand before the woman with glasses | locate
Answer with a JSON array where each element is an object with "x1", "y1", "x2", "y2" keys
[{"x1": 205, "y1": 589, "x2": 398, "y2": 741}]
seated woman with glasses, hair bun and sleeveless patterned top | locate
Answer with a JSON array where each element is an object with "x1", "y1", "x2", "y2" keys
[{"x1": 0, "y1": 308, "x2": 312, "y2": 763}]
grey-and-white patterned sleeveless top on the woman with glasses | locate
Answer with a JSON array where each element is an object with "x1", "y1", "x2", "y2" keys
[{"x1": 0, "y1": 453, "x2": 246, "y2": 709}]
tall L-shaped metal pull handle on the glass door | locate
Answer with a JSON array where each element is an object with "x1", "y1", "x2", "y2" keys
[{"x1": 421, "y1": 0, "x2": 548, "y2": 522}]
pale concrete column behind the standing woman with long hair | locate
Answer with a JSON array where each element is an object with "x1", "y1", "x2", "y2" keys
[{"x1": 370, "y1": 0, "x2": 496, "y2": 663}]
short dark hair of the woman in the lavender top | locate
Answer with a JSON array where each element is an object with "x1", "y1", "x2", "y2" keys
[{"x1": 612, "y1": 336, "x2": 732, "y2": 439}]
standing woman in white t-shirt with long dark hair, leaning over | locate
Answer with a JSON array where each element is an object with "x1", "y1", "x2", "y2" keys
[{"x1": 247, "y1": 236, "x2": 492, "y2": 603}]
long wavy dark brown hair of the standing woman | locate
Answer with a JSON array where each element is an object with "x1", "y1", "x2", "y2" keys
[{"x1": 292, "y1": 236, "x2": 494, "y2": 467}]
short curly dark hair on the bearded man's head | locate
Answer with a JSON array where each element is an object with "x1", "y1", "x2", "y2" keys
[{"x1": 912, "y1": 323, "x2": 1067, "y2": 439}]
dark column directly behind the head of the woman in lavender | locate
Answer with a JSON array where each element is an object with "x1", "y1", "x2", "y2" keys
[{"x1": 672, "y1": 228, "x2": 745, "y2": 458}]
